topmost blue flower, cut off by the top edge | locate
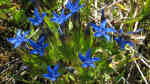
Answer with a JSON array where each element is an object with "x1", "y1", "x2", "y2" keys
[{"x1": 66, "y1": 0, "x2": 84, "y2": 13}]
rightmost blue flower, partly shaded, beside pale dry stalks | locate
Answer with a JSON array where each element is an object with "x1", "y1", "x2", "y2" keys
[{"x1": 115, "y1": 29, "x2": 134, "y2": 49}]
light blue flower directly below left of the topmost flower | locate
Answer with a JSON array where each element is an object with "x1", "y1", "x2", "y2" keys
[{"x1": 51, "y1": 9, "x2": 72, "y2": 24}]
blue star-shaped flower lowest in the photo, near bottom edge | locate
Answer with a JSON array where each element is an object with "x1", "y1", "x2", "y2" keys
[{"x1": 43, "y1": 64, "x2": 60, "y2": 81}]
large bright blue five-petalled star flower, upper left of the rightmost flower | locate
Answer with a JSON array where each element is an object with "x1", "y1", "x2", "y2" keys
[{"x1": 91, "y1": 19, "x2": 116, "y2": 40}]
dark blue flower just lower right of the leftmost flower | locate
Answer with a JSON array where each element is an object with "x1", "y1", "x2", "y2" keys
[{"x1": 29, "y1": 36, "x2": 48, "y2": 56}]
